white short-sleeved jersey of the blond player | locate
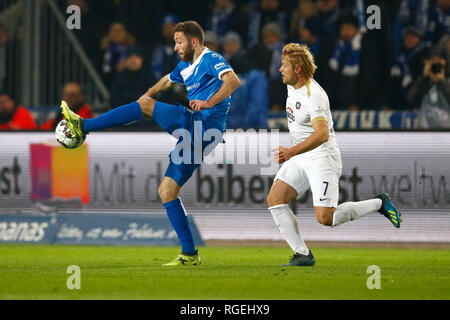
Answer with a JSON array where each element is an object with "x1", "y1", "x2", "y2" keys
[{"x1": 286, "y1": 79, "x2": 340, "y2": 158}]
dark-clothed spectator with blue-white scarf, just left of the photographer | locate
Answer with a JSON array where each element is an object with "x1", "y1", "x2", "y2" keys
[{"x1": 385, "y1": 26, "x2": 429, "y2": 109}]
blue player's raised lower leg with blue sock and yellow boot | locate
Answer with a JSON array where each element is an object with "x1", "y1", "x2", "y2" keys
[{"x1": 61, "y1": 101, "x2": 142, "y2": 137}]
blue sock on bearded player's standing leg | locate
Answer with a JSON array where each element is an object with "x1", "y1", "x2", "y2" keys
[{"x1": 164, "y1": 198, "x2": 196, "y2": 254}]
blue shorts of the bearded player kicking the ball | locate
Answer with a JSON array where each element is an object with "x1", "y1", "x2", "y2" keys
[{"x1": 152, "y1": 101, "x2": 223, "y2": 187}]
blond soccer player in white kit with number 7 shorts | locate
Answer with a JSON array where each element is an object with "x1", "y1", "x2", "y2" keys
[{"x1": 267, "y1": 43, "x2": 401, "y2": 266}]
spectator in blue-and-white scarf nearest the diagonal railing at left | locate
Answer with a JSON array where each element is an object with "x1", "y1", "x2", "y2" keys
[{"x1": 100, "y1": 22, "x2": 135, "y2": 84}]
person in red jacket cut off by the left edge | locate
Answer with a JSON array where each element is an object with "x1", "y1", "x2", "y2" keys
[{"x1": 0, "y1": 93, "x2": 37, "y2": 130}]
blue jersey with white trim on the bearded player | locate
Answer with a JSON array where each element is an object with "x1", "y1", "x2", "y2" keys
[{"x1": 169, "y1": 48, "x2": 233, "y2": 130}]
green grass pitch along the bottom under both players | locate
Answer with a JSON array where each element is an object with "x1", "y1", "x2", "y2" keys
[{"x1": 0, "y1": 245, "x2": 450, "y2": 300}]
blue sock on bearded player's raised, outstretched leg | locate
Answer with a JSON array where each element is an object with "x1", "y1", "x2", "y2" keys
[{"x1": 83, "y1": 102, "x2": 142, "y2": 133}]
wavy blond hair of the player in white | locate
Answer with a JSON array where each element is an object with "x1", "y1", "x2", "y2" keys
[{"x1": 282, "y1": 43, "x2": 317, "y2": 96}]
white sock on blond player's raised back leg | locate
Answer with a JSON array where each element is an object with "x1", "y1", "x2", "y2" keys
[{"x1": 333, "y1": 199, "x2": 382, "y2": 227}]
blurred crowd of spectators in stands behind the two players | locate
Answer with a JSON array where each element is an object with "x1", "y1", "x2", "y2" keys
[{"x1": 0, "y1": 0, "x2": 450, "y2": 128}]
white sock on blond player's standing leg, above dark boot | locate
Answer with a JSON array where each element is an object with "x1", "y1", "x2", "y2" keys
[{"x1": 269, "y1": 204, "x2": 309, "y2": 255}]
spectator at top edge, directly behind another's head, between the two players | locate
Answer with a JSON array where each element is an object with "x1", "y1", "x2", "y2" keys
[{"x1": 248, "y1": 0, "x2": 289, "y2": 48}]
